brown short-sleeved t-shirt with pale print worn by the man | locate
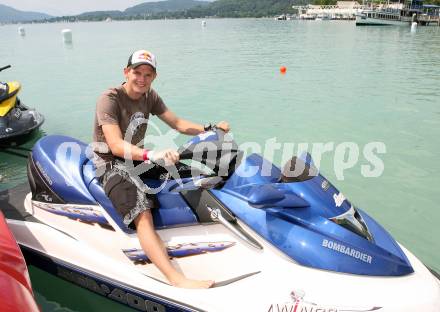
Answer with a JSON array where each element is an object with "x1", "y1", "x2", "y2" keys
[{"x1": 93, "y1": 85, "x2": 167, "y2": 165}]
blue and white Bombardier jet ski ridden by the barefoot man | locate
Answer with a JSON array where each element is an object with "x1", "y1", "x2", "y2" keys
[{"x1": 3, "y1": 130, "x2": 440, "y2": 312}]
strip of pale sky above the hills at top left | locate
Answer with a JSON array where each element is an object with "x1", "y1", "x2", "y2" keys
[{"x1": 0, "y1": 0, "x2": 155, "y2": 16}]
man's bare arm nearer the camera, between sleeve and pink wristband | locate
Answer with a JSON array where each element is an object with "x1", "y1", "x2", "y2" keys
[{"x1": 102, "y1": 125, "x2": 144, "y2": 160}]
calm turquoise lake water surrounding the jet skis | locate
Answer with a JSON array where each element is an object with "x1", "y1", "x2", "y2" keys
[{"x1": 0, "y1": 19, "x2": 440, "y2": 311}]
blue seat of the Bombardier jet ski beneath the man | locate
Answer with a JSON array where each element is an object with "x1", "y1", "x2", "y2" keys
[{"x1": 32, "y1": 135, "x2": 198, "y2": 233}]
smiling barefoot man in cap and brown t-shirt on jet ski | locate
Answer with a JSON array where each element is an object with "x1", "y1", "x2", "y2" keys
[{"x1": 93, "y1": 50, "x2": 229, "y2": 288}]
